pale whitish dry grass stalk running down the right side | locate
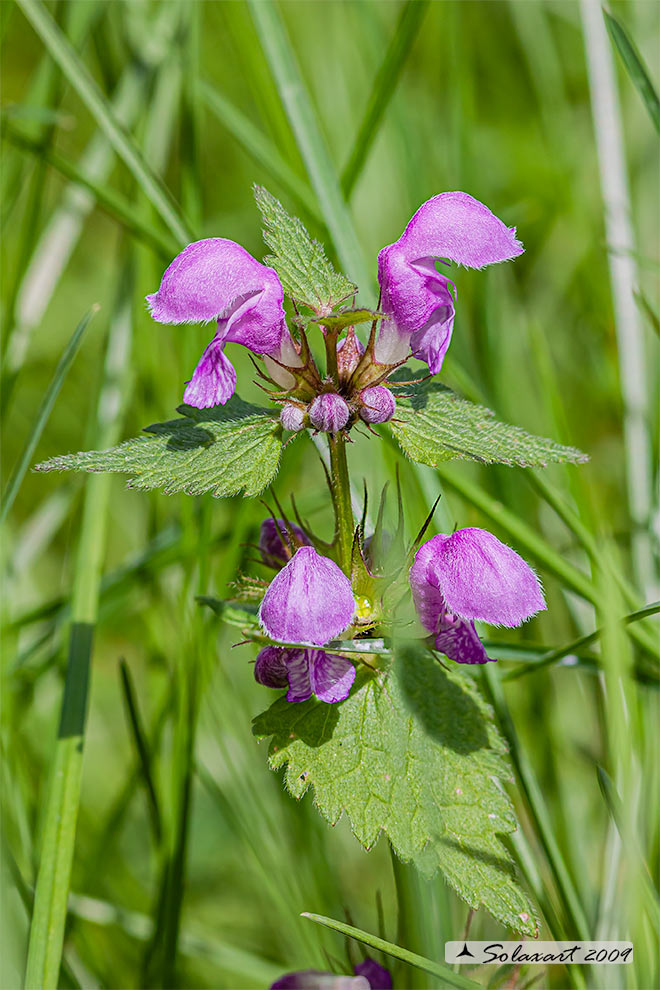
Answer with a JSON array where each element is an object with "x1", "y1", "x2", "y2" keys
[{"x1": 580, "y1": 0, "x2": 659, "y2": 600}]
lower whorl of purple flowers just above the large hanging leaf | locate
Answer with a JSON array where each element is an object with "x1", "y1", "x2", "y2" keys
[{"x1": 254, "y1": 519, "x2": 546, "y2": 703}]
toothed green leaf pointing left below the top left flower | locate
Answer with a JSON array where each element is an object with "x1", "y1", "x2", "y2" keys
[{"x1": 35, "y1": 396, "x2": 282, "y2": 496}]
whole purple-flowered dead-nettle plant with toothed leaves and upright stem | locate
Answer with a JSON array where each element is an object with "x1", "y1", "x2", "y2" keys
[{"x1": 34, "y1": 188, "x2": 585, "y2": 935}]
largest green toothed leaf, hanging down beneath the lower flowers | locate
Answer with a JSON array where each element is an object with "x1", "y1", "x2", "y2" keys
[{"x1": 253, "y1": 644, "x2": 536, "y2": 935}]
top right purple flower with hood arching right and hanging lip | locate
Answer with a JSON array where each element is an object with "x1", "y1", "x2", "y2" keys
[{"x1": 375, "y1": 192, "x2": 523, "y2": 375}]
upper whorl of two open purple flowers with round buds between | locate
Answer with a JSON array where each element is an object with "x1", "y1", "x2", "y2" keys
[{"x1": 147, "y1": 192, "x2": 523, "y2": 433}]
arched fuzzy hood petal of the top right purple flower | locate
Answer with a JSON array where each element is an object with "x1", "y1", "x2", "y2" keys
[{"x1": 390, "y1": 192, "x2": 524, "y2": 268}]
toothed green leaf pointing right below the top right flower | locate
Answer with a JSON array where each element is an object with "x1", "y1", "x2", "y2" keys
[{"x1": 390, "y1": 380, "x2": 588, "y2": 467}]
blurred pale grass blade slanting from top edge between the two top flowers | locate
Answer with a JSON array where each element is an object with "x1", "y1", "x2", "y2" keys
[{"x1": 249, "y1": 0, "x2": 372, "y2": 293}]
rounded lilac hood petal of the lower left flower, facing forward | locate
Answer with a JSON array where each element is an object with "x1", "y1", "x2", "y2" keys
[{"x1": 259, "y1": 547, "x2": 355, "y2": 646}]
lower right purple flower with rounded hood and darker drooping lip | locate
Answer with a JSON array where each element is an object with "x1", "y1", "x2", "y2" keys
[{"x1": 410, "y1": 528, "x2": 546, "y2": 663}]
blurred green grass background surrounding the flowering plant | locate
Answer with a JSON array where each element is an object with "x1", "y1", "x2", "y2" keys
[{"x1": 0, "y1": 0, "x2": 660, "y2": 988}]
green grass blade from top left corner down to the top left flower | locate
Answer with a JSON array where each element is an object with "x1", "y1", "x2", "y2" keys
[{"x1": 17, "y1": 0, "x2": 194, "y2": 244}]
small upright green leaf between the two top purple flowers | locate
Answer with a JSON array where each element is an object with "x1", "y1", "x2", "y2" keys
[{"x1": 254, "y1": 186, "x2": 357, "y2": 314}]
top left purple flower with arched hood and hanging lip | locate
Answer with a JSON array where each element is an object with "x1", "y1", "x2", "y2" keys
[{"x1": 147, "y1": 237, "x2": 300, "y2": 409}]
